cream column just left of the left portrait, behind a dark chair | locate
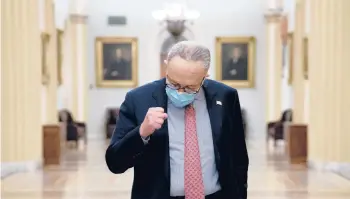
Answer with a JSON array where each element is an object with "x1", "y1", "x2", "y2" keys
[{"x1": 64, "y1": 14, "x2": 88, "y2": 122}]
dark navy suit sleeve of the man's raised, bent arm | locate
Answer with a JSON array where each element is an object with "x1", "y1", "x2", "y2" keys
[{"x1": 105, "y1": 93, "x2": 145, "y2": 174}]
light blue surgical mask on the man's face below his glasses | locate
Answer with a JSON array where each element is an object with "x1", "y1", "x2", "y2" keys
[{"x1": 165, "y1": 87, "x2": 196, "y2": 108}]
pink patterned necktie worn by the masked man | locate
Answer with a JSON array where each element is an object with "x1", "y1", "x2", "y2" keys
[{"x1": 185, "y1": 105, "x2": 205, "y2": 199}]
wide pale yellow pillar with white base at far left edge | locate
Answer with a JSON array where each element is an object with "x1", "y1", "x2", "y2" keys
[{"x1": 1, "y1": 0, "x2": 42, "y2": 177}]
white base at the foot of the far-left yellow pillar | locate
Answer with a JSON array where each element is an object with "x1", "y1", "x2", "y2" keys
[{"x1": 1, "y1": 161, "x2": 43, "y2": 179}]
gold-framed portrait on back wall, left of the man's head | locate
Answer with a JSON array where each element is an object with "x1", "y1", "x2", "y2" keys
[{"x1": 95, "y1": 37, "x2": 138, "y2": 88}]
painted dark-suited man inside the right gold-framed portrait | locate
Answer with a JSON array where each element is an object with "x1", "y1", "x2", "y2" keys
[{"x1": 222, "y1": 47, "x2": 248, "y2": 80}]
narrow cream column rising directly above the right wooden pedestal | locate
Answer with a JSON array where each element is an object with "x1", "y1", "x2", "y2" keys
[{"x1": 292, "y1": 0, "x2": 305, "y2": 124}]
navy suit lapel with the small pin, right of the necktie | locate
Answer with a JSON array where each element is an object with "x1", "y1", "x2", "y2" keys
[{"x1": 203, "y1": 80, "x2": 223, "y2": 169}]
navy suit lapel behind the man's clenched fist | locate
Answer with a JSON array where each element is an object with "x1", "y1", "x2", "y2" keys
[{"x1": 152, "y1": 78, "x2": 170, "y2": 191}]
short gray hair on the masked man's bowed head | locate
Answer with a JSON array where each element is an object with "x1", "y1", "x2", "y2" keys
[{"x1": 167, "y1": 41, "x2": 210, "y2": 69}]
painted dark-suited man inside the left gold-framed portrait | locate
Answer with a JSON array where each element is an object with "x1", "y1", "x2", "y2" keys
[{"x1": 104, "y1": 48, "x2": 131, "y2": 80}]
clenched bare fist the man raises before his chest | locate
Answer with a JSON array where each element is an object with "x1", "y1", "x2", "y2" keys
[{"x1": 140, "y1": 107, "x2": 168, "y2": 137}]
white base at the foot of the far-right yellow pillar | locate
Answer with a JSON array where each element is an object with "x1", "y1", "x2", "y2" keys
[{"x1": 308, "y1": 161, "x2": 350, "y2": 180}]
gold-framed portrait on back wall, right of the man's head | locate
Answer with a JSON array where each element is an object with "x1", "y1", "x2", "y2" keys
[{"x1": 215, "y1": 37, "x2": 256, "y2": 88}]
